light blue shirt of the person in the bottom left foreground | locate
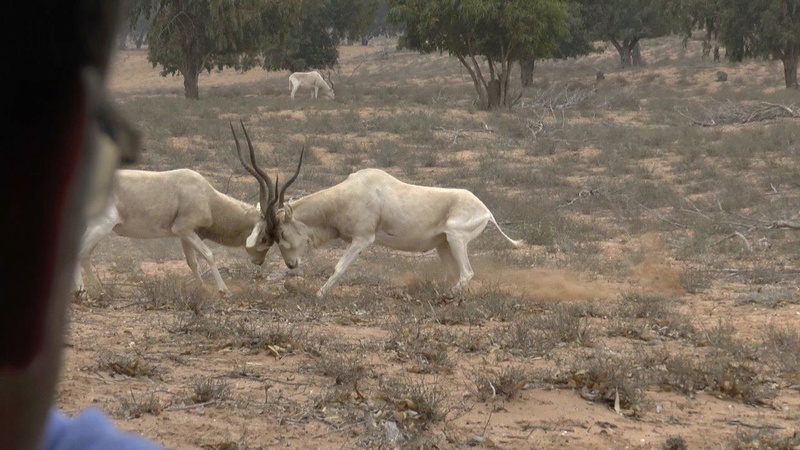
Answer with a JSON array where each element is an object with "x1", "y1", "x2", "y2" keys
[{"x1": 44, "y1": 408, "x2": 163, "y2": 450}]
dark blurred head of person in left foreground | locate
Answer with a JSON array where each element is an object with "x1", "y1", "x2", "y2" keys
[{"x1": 0, "y1": 0, "x2": 137, "y2": 449}]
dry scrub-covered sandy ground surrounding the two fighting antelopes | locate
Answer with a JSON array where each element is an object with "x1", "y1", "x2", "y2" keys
[{"x1": 57, "y1": 38, "x2": 800, "y2": 450}]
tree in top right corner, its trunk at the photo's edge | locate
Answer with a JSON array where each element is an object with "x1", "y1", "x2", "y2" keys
[{"x1": 718, "y1": 0, "x2": 800, "y2": 89}]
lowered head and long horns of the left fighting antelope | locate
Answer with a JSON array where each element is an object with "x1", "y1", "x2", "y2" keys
[{"x1": 230, "y1": 121, "x2": 278, "y2": 266}]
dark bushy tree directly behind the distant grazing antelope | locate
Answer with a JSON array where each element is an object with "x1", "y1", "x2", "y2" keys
[{"x1": 262, "y1": 0, "x2": 378, "y2": 72}]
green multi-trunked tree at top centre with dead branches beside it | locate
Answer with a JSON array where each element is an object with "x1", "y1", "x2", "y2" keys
[{"x1": 388, "y1": 0, "x2": 567, "y2": 109}]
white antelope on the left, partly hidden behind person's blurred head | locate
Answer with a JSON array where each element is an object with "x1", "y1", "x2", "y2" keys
[{"x1": 75, "y1": 124, "x2": 276, "y2": 296}]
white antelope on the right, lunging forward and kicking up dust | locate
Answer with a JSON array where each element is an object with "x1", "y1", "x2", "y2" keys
[{"x1": 248, "y1": 152, "x2": 524, "y2": 297}]
